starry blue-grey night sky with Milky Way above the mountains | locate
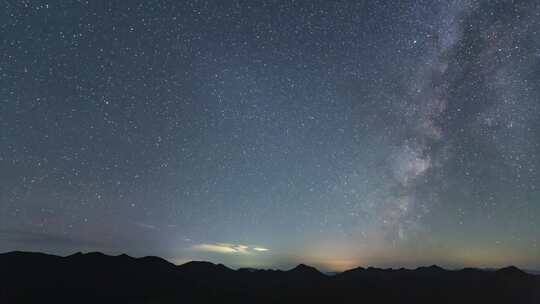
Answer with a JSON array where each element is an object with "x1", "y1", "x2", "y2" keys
[{"x1": 0, "y1": 0, "x2": 540, "y2": 270}]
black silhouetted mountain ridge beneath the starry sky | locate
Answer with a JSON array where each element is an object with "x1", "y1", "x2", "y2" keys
[{"x1": 0, "y1": 252, "x2": 540, "y2": 304}]
